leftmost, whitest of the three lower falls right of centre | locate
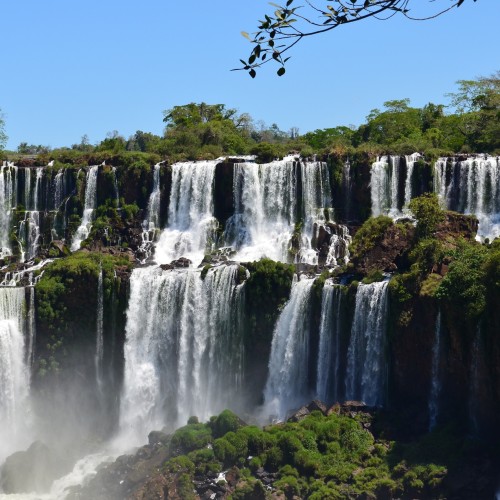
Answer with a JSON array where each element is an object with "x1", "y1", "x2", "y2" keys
[{"x1": 264, "y1": 277, "x2": 314, "y2": 418}]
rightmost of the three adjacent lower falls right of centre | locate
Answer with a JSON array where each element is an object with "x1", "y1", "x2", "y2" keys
[{"x1": 345, "y1": 281, "x2": 388, "y2": 406}]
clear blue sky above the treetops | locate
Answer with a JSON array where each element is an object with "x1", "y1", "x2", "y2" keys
[{"x1": 0, "y1": 0, "x2": 500, "y2": 149}]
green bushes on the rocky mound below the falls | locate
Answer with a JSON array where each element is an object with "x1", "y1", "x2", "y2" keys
[{"x1": 164, "y1": 410, "x2": 450, "y2": 499}]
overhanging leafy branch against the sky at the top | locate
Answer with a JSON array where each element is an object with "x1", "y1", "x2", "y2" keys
[{"x1": 236, "y1": 0, "x2": 476, "y2": 78}]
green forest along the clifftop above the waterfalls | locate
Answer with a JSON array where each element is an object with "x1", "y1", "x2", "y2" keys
[{"x1": 2, "y1": 73, "x2": 500, "y2": 161}]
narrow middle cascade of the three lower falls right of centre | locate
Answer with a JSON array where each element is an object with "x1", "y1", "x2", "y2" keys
[{"x1": 316, "y1": 281, "x2": 342, "y2": 402}]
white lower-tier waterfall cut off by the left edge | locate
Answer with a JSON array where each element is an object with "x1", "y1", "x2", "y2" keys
[{"x1": 0, "y1": 287, "x2": 30, "y2": 464}]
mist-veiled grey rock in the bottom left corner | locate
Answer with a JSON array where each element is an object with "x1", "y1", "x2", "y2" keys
[{"x1": 0, "y1": 441, "x2": 71, "y2": 493}]
